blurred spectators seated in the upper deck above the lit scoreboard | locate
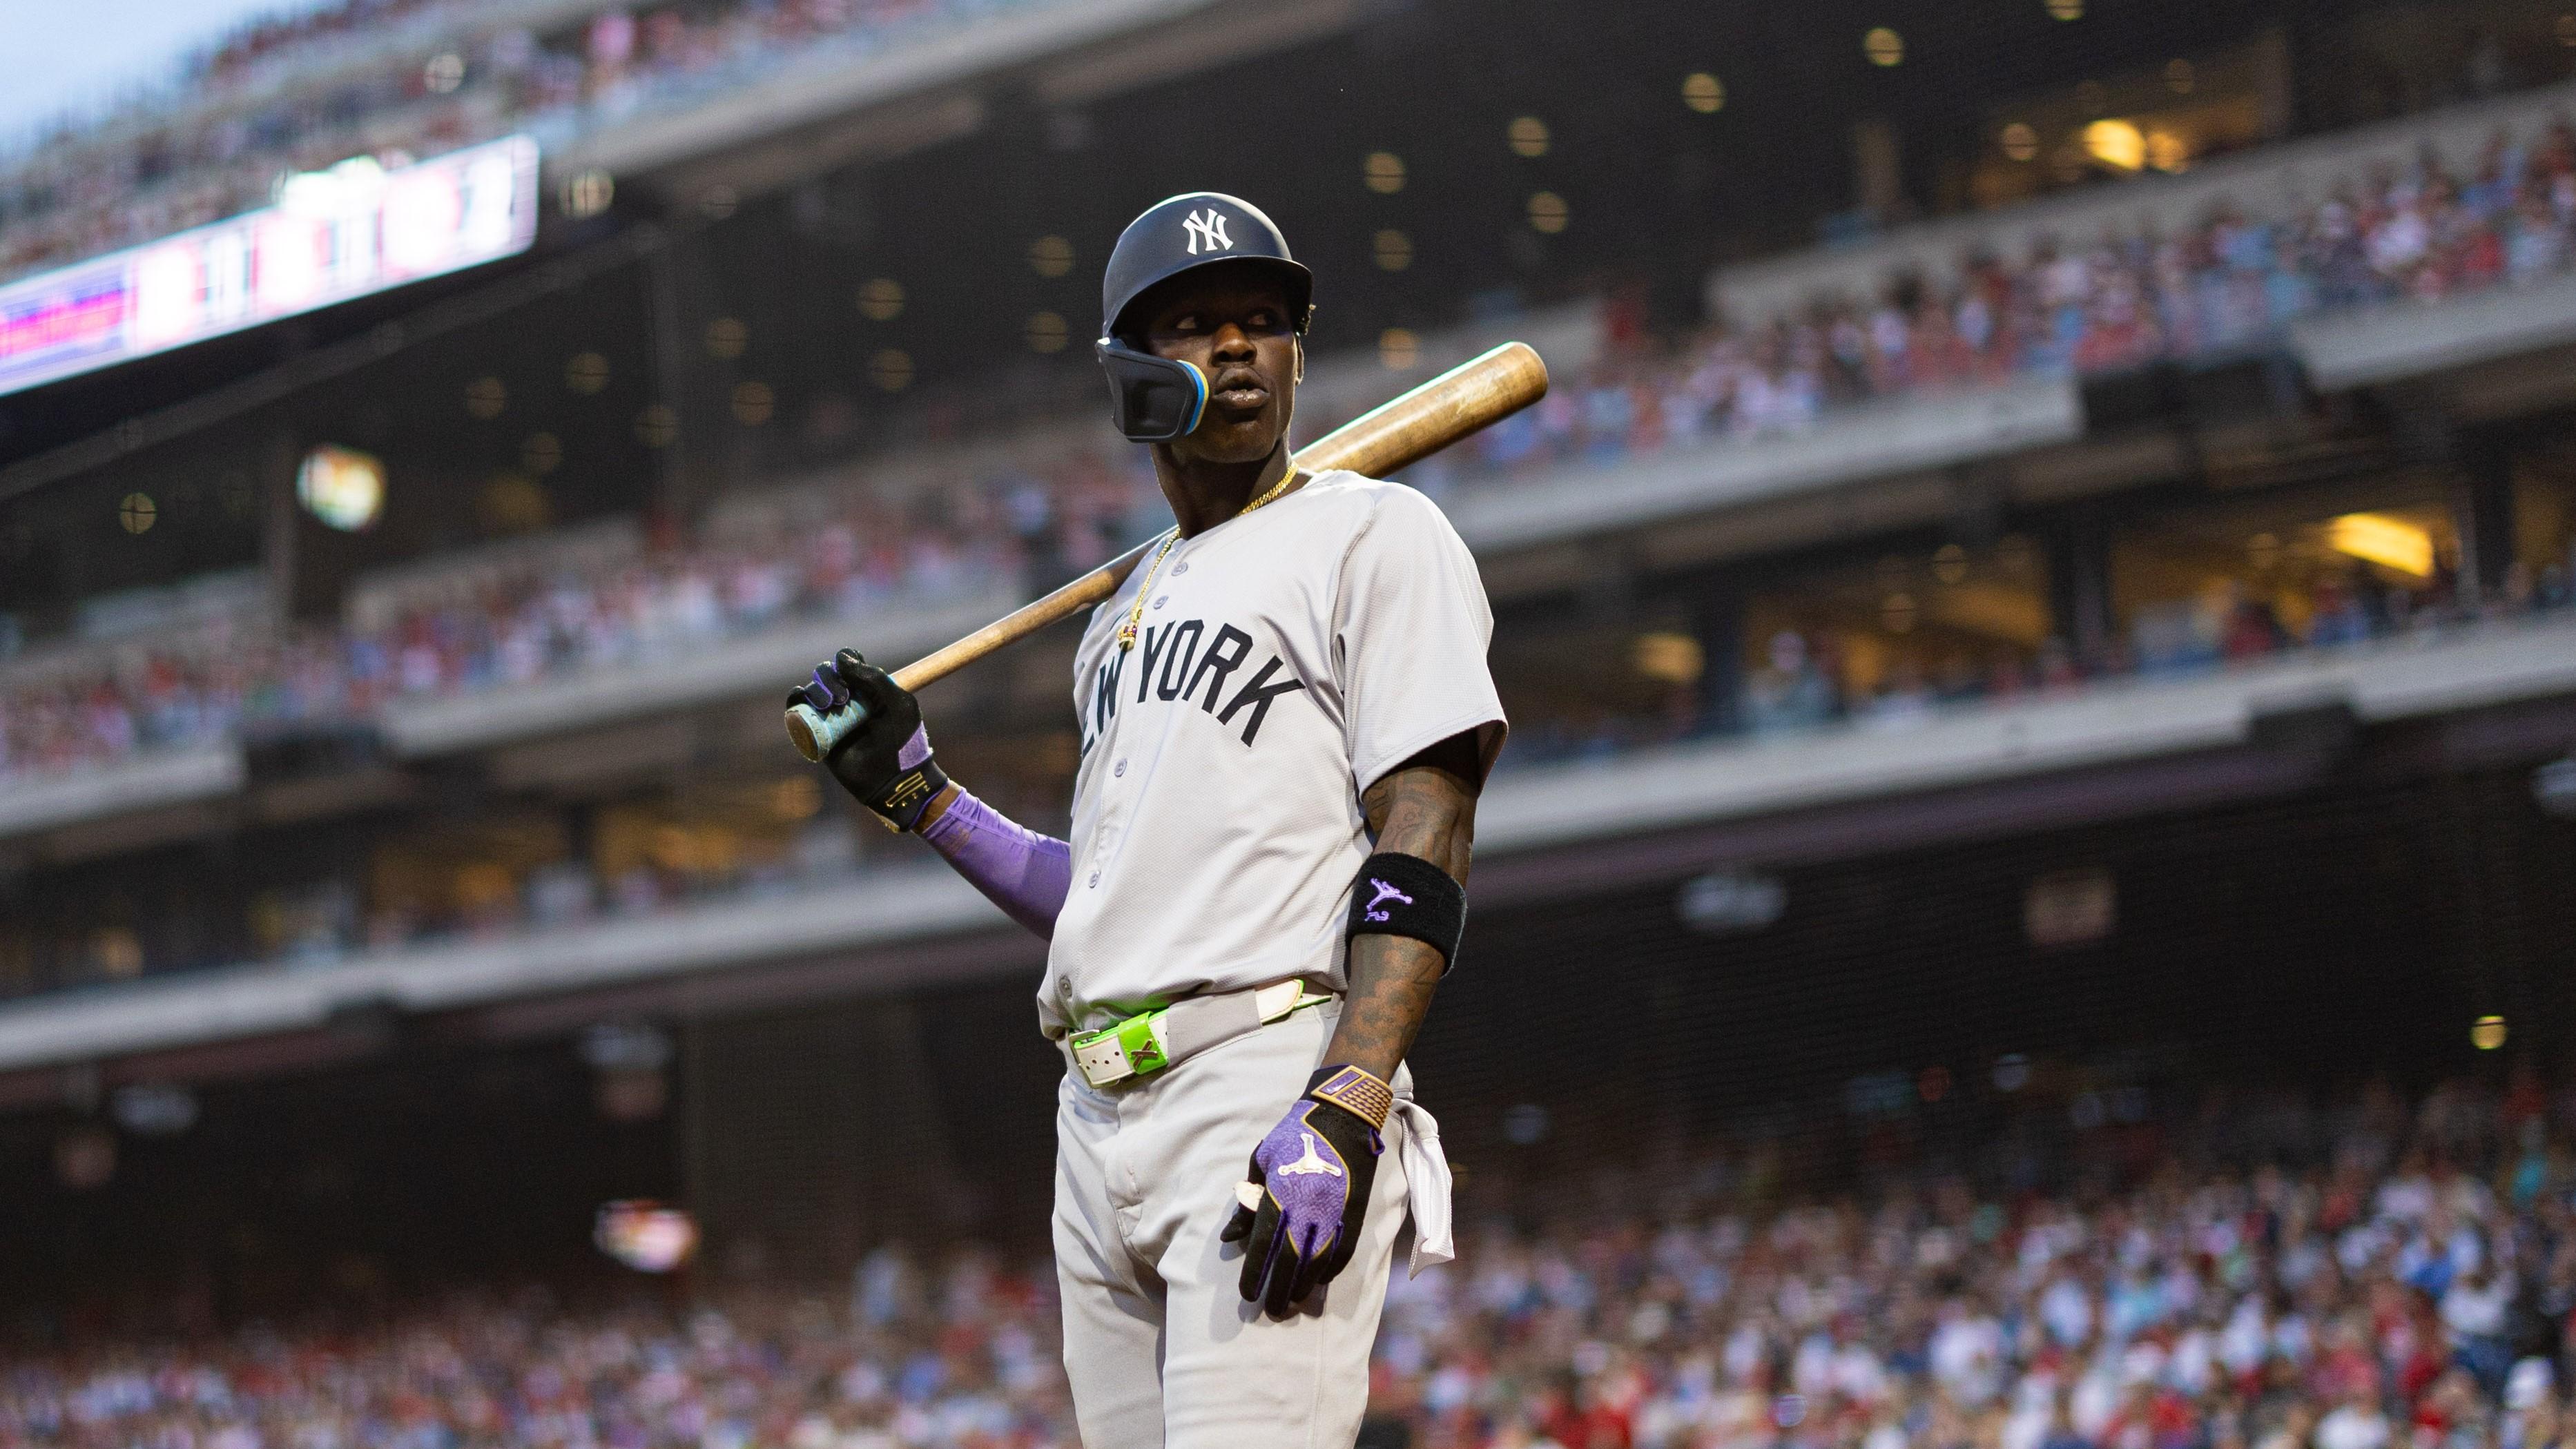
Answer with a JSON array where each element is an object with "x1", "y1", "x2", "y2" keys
[{"x1": 0, "y1": 0, "x2": 1066, "y2": 280}]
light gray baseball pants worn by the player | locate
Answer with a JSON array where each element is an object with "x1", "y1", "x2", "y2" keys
[{"x1": 1056, "y1": 1004, "x2": 1412, "y2": 1449}]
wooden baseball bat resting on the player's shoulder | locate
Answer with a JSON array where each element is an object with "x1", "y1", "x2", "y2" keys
[{"x1": 788, "y1": 342, "x2": 1548, "y2": 759}]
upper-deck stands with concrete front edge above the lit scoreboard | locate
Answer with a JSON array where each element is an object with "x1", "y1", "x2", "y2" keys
[{"x1": 0, "y1": 0, "x2": 1252, "y2": 280}]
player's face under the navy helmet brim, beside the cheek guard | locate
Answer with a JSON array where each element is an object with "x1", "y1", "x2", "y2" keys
[{"x1": 1144, "y1": 278, "x2": 1298, "y2": 463}]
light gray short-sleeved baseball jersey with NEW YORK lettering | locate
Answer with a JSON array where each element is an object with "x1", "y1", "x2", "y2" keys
[{"x1": 1038, "y1": 471, "x2": 1504, "y2": 1035}]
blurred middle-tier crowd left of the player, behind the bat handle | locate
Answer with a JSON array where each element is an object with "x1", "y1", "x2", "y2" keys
[{"x1": 0, "y1": 456, "x2": 1152, "y2": 782}]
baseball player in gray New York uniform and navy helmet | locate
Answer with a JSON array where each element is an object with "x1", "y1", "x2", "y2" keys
[{"x1": 791, "y1": 193, "x2": 1504, "y2": 1449}]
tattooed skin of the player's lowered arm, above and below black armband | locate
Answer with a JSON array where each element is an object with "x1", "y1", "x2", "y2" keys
[{"x1": 1324, "y1": 734, "x2": 1481, "y2": 1078}]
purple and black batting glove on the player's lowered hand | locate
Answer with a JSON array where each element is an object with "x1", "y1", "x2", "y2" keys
[{"x1": 1219, "y1": 1065, "x2": 1386, "y2": 1318}]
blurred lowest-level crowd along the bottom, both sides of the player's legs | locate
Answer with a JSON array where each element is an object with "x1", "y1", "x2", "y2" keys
[{"x1": 0, "y1": 1076, "x2": 2576, "y2": 1449}]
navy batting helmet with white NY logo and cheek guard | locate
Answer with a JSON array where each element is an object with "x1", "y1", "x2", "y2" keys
[{"x1": 1095, "y1": 191, "x2": 1314, "y2": 443}]
